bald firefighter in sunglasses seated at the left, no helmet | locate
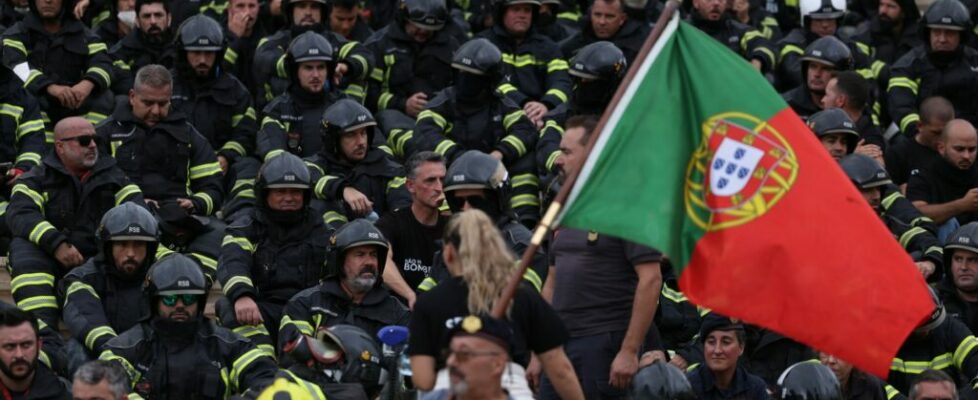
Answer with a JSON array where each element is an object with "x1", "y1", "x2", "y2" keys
[{"x1": 7, "y1": 117, "x2": 143, "y2": 326}]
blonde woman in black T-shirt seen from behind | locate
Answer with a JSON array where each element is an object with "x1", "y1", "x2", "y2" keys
[{"x1": 408, "y1": 210, "x2": 584, "y2": 399}]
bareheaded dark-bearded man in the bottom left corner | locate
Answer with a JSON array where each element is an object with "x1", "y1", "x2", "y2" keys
[{"x1": 0, "y1": 308, "x2": 71, "y2": 400}]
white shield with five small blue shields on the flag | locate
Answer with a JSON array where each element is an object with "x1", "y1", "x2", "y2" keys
[{"x1": 710, "y1": 138, "x2": 764, "y2": 197}]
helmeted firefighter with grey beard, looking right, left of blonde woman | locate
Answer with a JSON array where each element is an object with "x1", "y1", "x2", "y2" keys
[{"x1": 278, "y1": 219, "x2": 410, "y2": 349}]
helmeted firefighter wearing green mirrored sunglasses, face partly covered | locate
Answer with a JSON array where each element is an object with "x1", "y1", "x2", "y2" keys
[{"x1": 100, "y1": 254, "x2": 278, "y2": 399}]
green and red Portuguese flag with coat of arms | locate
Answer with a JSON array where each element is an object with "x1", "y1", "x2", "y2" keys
[{"x1": 559, "y1": 17, "x2": 934, "y2": 378}]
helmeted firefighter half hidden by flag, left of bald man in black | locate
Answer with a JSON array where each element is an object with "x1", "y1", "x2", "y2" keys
[{"x1": 839, "y1": 154, "x2": 945, "y2": 282}]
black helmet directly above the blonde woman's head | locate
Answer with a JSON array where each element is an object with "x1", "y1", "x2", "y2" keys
[{"x1": 444, "y1": 150, "x2": 510, "y2": 220}]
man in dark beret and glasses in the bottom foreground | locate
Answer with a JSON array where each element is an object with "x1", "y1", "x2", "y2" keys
[{"x1": 422, "y1": 315, "x2": 513, "y2": 400}]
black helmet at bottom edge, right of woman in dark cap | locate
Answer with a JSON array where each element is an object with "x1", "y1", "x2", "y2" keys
[{"x1": 778, "y1": 361, "x2": 842, "y2": 400}]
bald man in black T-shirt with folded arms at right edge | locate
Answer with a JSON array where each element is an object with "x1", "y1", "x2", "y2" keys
[{"x1": 907, "y1": 119, "x2": 978, "y2": 236}]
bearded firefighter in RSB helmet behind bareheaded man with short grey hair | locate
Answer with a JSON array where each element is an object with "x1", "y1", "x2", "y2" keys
[{"x1": 172, "y1": 15, "x2": 258, "y2": 177}]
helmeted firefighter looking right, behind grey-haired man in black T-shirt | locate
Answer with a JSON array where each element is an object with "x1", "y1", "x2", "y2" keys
[{"x1": 306, "y1": 99, "x2": 411, "y2": 227}]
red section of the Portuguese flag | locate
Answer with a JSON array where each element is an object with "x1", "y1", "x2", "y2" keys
[{"x1": 680, "y1": 109, "x2": 934, "y2": 379}]
